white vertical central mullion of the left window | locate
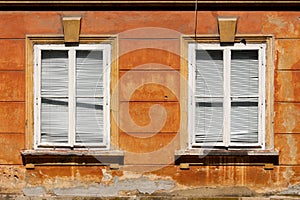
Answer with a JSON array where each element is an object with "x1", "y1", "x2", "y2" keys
[{"x1": 69, "y1": 48, "x2": 76, "y2": 147}]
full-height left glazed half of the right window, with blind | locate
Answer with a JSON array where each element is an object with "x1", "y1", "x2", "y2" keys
[{"x1": 194, "y1": 50, "x2": 223, "y2": 144}]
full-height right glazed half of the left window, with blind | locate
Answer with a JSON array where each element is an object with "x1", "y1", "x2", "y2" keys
[{"x1": 75, "y1": 50, "x2": 104, "y2": 145}]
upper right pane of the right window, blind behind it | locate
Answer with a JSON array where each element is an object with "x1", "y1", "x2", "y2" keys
[{"x1": 230, "y1": 50, "x2": 259, "y2": 96}]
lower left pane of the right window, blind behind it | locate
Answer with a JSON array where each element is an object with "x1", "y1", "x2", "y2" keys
[{"x1": 195, "y1": 98, "x2": 223, "y2": 143}]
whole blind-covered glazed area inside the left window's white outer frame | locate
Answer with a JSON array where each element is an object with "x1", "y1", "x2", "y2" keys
[{"x1": 40, "y1": 50, "x2": 105, "y2": 146}]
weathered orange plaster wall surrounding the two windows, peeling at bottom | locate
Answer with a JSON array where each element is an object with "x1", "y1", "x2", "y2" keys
[{"x1": 0, "y1": 11, "x2": 300, "y2": 196}]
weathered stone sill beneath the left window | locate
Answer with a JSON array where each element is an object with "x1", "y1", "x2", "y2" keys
[{"x1": 21, "y1": 150, "x2": 124, "y2": 165}]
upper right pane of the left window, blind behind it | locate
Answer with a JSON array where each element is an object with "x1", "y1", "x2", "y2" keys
[{"x1": 76, "y1": 51, "x2": 103, "y2": 97}]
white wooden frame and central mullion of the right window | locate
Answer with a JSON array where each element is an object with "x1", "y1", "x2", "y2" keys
[{"x1": 188, "y1": 43, "x2": 266, "y2": 149}]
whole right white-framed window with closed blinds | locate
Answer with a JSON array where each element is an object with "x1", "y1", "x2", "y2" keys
[{"x1": 188, "y1": 43, "x2": 266, "y2": 149}]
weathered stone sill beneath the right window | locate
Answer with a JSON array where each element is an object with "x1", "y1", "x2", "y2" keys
[{"x1": 175, "y1": 149, "x2": 279, "y2": 166}]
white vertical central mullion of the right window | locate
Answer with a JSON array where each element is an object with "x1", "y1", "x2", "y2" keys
[{"x1": 223, "y1": 48, "x2": 231, "y2": 147}]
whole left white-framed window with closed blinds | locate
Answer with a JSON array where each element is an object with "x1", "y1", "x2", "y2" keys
[{"x1": 34, "y1": 44, "x2": 111, "y2": 149}]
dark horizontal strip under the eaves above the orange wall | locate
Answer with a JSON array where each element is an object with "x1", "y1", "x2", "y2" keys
[{"x1": 0, "y1": 1, "x2": 300, "y2": 11}]
